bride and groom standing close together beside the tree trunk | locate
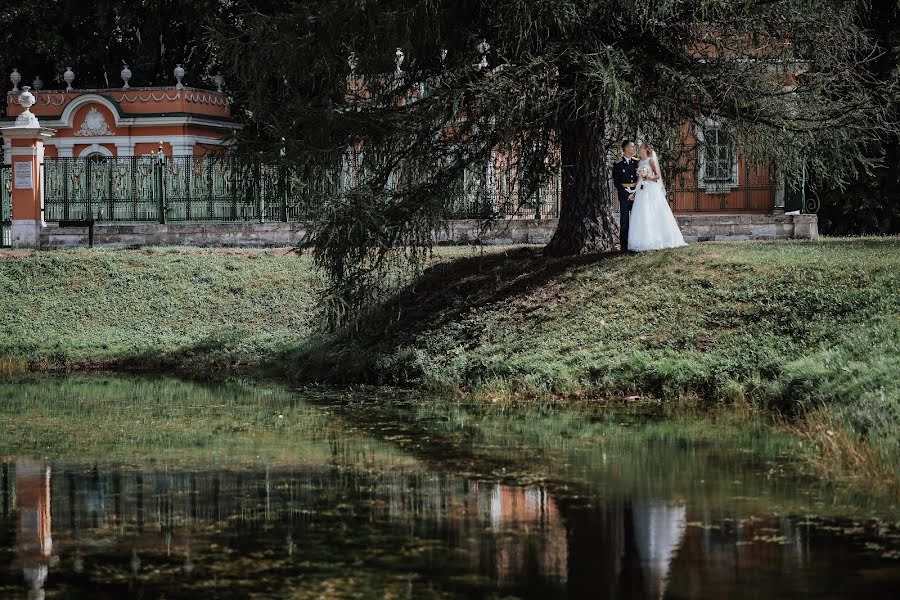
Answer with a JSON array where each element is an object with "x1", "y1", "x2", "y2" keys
[{"x1": 613, "y1": 140, "x2": 685, "y2": 252}]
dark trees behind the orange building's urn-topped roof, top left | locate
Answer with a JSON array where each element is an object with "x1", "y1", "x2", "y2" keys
[{"x1": 0, "y1": 0, "x2": 231, "y2": 105}]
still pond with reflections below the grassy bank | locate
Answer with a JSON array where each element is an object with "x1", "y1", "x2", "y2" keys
[{"x1": 0, "y1": 376, "x2": 900, "y2": 599}]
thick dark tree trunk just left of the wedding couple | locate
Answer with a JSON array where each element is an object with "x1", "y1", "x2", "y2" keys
[{"x1": 544, "y1": 117, "x2": 619, "y2": 256}]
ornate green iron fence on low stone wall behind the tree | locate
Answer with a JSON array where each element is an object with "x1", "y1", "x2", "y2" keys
[{"x1": 44, "y1": 154, "x2": 560, "y2": 223}]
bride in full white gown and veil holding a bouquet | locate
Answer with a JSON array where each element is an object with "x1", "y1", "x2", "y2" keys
[{"x1": 628, "y1": 142, "x2": 687, "y2": 252}]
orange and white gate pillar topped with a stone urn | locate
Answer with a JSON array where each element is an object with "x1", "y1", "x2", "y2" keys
[{"x1": 0, "y1": 87, "x2": 55, "y2": 248}]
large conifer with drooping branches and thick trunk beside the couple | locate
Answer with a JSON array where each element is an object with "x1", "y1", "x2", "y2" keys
[{"x1": 230, "y1": 0, "x2": 894, "y2": 318}]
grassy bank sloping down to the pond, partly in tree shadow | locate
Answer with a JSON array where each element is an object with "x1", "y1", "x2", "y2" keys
[{"x1": 0, "y1": 239, "x2": 900, "y2": 477}]
